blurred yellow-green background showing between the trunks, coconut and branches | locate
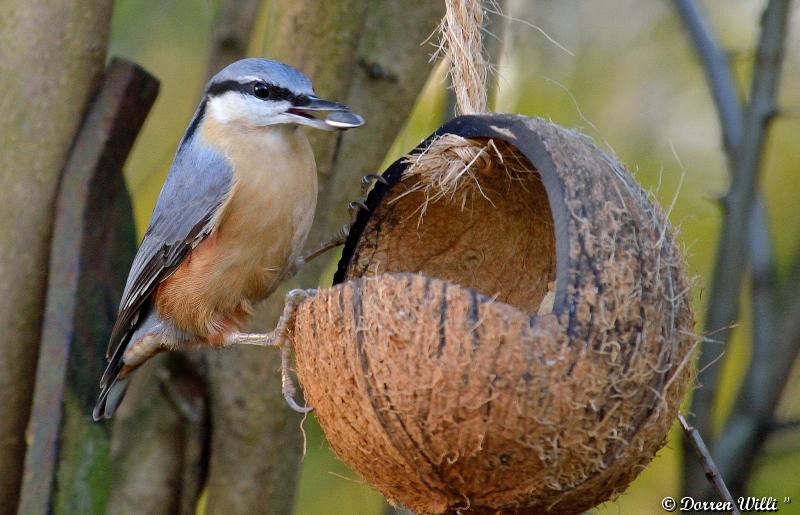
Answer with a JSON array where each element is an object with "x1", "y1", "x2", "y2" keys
[{"x1": 110, "y1": 0, "x2": 800, "y2": 514}]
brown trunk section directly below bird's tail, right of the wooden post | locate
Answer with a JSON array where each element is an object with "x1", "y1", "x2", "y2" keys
[{"x1": 106, "y1": 355, "x2": 208, "y2": 515}]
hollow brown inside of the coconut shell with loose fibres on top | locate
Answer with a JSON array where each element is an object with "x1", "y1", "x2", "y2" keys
[{"x1": 347, "y1": 134, "x2": 556, "y2": 313}]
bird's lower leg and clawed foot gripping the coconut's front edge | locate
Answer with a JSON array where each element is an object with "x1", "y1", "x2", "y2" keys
[{"x1": 225, "y1": 289, "x2": 317, "y2": 413}]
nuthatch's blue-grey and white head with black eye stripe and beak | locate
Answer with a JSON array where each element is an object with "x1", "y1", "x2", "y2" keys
[{"x1": 204, "y1": 58, "x2": 364, "y2": 131}]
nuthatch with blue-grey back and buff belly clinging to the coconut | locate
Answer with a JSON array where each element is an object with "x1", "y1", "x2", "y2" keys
[{"x1": 93, "y1": 59, "x2": 363, "y2": 420}]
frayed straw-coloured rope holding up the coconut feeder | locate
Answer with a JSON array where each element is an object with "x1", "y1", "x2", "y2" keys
[{"x1": 439, "y1": 0, "x2": 489, "y2": 114}]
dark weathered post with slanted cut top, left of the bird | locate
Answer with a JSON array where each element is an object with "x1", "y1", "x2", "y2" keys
[{"x1": 19, "y1": 59, "x2": 158, "y2": 514}]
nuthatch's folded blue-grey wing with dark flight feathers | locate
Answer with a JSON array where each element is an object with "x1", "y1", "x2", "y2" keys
[{"x1": 101, "y1": 138, "x2": 233, "y2": 366}]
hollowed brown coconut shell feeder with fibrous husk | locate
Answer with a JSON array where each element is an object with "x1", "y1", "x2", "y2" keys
[{"x1": 293, "y1": 115, "x2": 695, "y2": 513}]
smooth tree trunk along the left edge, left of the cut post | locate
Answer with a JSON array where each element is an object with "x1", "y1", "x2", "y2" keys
[{"x1": 0, "y1": 0, "x2": 112, "y2": 513}]
